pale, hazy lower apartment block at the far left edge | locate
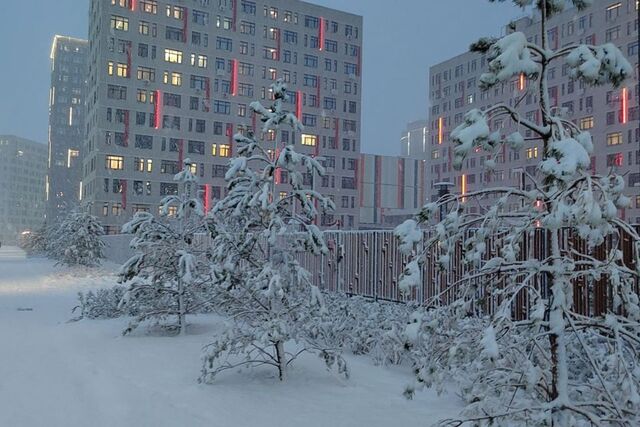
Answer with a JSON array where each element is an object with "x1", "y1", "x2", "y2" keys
[{"x1": 0, "y1": 135, "x2": 47, "y2": 243}]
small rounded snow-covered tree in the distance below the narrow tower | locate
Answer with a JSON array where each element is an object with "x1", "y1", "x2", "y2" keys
[{"x1": 45, "y1": 209, "x2": 104, "y2": 267}]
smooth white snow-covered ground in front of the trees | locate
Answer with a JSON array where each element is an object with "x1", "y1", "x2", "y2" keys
[{"x1": 0, "y1": 247, "x2": 458, "y2": 427}]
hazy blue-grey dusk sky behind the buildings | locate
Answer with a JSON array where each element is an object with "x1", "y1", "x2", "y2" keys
[{"x1": 0, "y1": 0, "x2": 522, "y2": 154}]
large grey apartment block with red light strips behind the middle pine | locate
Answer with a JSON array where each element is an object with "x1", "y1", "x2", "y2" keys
[{"x1": 82, "y1": 0, "x2": 362, "y2": 233}]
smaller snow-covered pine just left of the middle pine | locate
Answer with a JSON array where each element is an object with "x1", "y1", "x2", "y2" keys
[{"x1": 118, "y1": 159, "x2": 208, "y2": 334}]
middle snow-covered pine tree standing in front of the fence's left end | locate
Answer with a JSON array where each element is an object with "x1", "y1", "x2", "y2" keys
[{"x1": 201, "y1": 80, "x2": 347, "y2": 382}]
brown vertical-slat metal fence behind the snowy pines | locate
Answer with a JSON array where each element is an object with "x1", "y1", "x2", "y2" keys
[{"x1": 300, "y1": 226, "x2": 640, "y2": 318}]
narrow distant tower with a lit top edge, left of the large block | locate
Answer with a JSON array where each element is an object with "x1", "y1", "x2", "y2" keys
[{"x1": 46, "y1": 36, "x2": 89, "y2": 221}]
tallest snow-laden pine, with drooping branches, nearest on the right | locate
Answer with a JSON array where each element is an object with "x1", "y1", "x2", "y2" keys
[{"x1": 396, "y1": 0, "x2": 640, "y2": 426}]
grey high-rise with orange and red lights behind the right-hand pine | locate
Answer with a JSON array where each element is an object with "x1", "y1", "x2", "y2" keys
[{"x1": 427, "y1": 0, "x2": 640, "y2": 223}]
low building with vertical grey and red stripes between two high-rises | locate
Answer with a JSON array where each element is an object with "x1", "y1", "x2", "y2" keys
[{"x1": 358, "y1": 154, "x2": 427, "y2": 228}]
